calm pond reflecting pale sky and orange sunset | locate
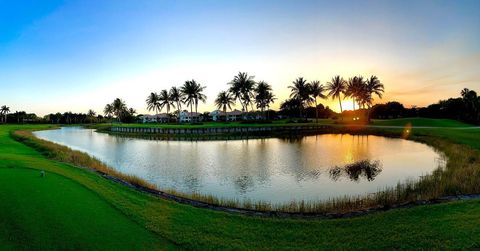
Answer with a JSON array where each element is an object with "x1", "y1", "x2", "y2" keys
[{"x1": 35, "y1": 127, "x2": 444, "y2": 204}]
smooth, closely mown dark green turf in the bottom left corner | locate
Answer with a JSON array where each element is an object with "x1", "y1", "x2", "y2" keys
[{"x1": 0, "y1": 168, "x2": 174, "y2": 250}]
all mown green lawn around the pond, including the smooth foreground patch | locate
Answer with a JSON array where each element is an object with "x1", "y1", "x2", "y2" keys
[{"x1": 0, "y1": 122, "x2": 480, "y2": 250}]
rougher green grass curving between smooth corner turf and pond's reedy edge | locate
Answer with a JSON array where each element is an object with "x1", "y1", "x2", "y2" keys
[{"x1": 0, "y1": 120, "x2": 480, "y2": 250}]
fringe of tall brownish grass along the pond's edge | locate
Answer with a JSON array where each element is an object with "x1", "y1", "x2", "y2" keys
[{"x1": 13, "y1": 119, "x2": 480, "y2": 214}]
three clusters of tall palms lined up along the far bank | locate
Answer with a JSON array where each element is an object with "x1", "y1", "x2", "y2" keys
[{"x1": 141, "y1": 72, "x2": 384, "y2": 122}]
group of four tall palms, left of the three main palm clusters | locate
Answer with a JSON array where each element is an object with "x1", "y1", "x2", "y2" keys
[{"x1": 146, "y1": 79, "x2": 207, "y2": 121}]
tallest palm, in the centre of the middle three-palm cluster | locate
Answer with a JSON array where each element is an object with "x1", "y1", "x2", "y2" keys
[{"x1": 229, "y1": 72, "x2": 255, "y2": 112}]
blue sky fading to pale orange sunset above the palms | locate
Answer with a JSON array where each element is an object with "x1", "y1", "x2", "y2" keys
[{"x1": 0, "y1": 0, "x2": 480, "y2": 115}]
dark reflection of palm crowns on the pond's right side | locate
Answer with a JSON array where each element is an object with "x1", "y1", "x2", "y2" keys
[{"x1": 329, "y1": 160, "x2": 382, "y2": 182}]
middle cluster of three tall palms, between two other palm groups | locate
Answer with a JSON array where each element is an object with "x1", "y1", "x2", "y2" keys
[{"x1": 215, "y1": 72, "x2": 276, "y2": 119}]
